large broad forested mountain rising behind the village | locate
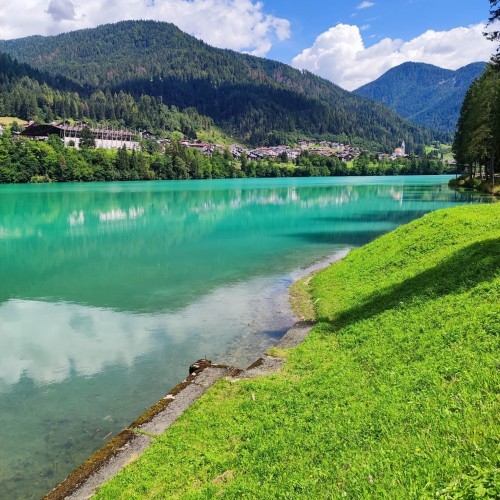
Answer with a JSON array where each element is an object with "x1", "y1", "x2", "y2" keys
[{"x1": 0, "y1": 21, "x2": 449, "y2": 149}]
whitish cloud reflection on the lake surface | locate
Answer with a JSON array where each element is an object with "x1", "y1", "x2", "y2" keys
[{"x1": 0, "y1": 277, "x2": 291, "y2": 390}]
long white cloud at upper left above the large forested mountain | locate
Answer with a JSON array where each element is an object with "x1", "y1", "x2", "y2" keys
[{"x1": 0, "y1": 0, "x2": 290, "y2": 56}]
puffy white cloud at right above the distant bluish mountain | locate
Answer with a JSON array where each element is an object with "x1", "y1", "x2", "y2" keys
[{"x1": 292, "y1": 24, "x2": 495, "y2": 90}]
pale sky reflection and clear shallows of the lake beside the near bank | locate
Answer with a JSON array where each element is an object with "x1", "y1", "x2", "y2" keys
[{"x1": 0, "y1": 268, "x2": 324, "y2": 498}]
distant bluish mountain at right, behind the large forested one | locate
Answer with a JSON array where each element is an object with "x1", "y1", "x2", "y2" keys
[{"x1": 354, "y1": 62, "x2": 486, "y2": 132}]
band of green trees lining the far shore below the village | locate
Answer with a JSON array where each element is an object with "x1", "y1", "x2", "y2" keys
[{"x1": 0, "y1": 132, "x2": 454, "y2": 183}]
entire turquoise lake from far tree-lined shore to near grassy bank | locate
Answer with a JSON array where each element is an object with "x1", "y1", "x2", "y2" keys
[{"x1": 0, "y1": 176, "x2": 487, "y2": 499}]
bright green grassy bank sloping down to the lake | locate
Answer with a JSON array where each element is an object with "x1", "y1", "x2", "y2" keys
[{"x1": 97, "y1": 203, "x2": 500, "y2": 499}]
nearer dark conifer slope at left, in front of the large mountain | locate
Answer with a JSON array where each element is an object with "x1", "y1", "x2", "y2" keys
[{"x1": 0, "y1": 52, "x2": 213, "y2": 137}]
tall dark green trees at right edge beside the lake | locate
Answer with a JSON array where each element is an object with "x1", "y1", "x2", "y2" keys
[{"x1": 453, "y1": 64, "x2": 500, "y2": 185}]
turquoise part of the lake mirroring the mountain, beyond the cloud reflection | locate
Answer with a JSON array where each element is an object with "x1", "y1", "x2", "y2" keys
[{"x1": 0, "y1": 178, "x2": 484, "y2": 313}]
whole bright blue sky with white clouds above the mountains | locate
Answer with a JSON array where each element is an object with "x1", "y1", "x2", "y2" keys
[{"x1": 0, "y1": 0, "x2": 496, "y2": 90}]
